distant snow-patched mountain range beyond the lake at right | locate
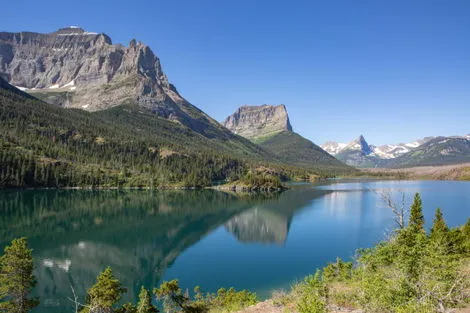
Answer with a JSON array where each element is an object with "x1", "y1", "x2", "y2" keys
[{"x1": 321, "y1": 134, "x2": 470, "y2": 167}]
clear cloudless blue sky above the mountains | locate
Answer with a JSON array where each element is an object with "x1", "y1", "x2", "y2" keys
[{"x1": 0, "y1": 0, "x2": 470, "y2": 144}]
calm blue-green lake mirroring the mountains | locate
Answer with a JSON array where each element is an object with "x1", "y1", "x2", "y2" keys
[{"x1": 0, "y1": 180, "x2": 470, "y2": 313}]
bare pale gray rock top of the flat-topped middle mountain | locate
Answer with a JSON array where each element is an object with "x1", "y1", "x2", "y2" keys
[{"x1": 224, "y1": 104, "x2": 292, "y2": 140}]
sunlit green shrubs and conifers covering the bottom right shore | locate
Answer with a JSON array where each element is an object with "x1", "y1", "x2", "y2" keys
[{"x1": 284, "y1": 195, "x2": 470, "y2": 313}]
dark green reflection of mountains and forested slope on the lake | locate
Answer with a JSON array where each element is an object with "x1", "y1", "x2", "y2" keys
[{"x1": 0, "y1": 189, "x2": 329, "y2": 312}]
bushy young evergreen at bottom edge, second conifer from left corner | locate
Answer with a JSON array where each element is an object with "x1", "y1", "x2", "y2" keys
[{"x1": 82, "y1": 267, "x2": 126, "y2": 313}]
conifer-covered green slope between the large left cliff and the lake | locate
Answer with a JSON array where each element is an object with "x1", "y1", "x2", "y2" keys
[{"x1": 0, "y1": 87, "x2": 346, "y2": 188}]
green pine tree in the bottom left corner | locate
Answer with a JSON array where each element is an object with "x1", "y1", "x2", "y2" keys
[{"x1": 0, "y1": 238, "x2": 39, "y2": 313}]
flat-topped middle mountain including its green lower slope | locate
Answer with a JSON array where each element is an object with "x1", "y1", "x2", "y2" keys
[{"x1": 224, "y1": 104, "x2": 352, "y2": 174}]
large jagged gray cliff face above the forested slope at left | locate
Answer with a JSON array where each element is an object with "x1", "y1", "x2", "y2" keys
[{"x1": 0, "y1": 27, "x2": 216, "y2": 131}]
